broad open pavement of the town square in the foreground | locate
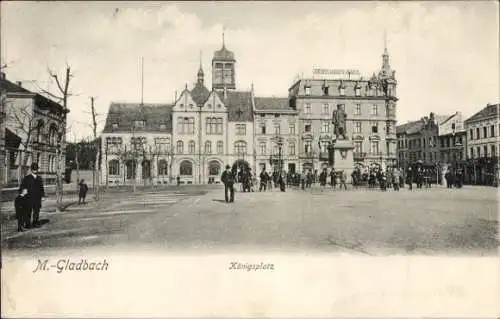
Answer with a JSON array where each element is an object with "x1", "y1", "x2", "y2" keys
[{"x1": 2, "y1": 186, "x2": 498, "y2": 256}]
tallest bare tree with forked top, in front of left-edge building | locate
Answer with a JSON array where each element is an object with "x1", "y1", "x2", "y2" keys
[{"x1": 41, "y1": 64, "x2": 74, "y2": 211}]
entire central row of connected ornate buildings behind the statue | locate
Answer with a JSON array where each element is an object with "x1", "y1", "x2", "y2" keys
[{"x1": 101, "y1": 36, "x2": 397, "y2": 184}]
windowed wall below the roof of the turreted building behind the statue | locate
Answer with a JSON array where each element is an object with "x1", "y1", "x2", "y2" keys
[{"x1": 296, "y1": 80, "x2": 397, "y2": 174}]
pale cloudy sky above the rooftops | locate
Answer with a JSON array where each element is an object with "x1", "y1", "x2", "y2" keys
[{"x1": 0, "y1": 1, "x2": 500, "y2": 140}]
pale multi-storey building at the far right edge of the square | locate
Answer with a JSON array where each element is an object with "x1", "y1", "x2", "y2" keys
[{"x1": 465, "y1": 104, "x2": 500, "y2": 185}]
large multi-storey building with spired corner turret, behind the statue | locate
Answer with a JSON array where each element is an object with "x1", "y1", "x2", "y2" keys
[{"x1": 289, "y1": 48, "x2": 398, "y2": 170}]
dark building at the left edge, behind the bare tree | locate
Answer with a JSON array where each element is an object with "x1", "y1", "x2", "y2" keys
[{"x1": 0, "y1": 73, "x2": 68, "y2": 186}]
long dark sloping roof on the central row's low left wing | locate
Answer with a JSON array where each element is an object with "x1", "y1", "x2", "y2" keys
[{"x1": 103, "y1": 102, "x2": 172, "y2": 133}]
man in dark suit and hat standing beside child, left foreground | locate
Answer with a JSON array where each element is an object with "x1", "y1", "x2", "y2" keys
[{"x1": 19, "y1": 163, "x2": 45, "y2": 228}]
